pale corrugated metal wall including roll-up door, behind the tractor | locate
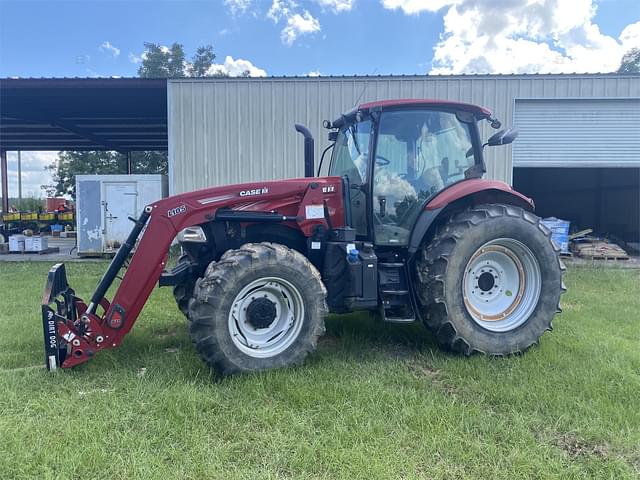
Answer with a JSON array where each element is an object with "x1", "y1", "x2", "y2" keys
[{"x1": 167, "y1": 74, "x2": 640, "y2": 193}]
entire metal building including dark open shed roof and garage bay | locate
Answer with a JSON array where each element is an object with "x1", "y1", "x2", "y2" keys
[{"x1": 0, "y1": 74, "x2": 640, "y2": 248}]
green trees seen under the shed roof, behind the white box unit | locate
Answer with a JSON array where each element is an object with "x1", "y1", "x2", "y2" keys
[{"x1": 42, "y1": 151, "x2": 168, "y2": 199}]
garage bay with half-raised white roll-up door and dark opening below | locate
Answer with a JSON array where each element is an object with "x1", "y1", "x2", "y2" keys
[{"x1": 513, "y1": 98, "x2": 640, "y2": 248}]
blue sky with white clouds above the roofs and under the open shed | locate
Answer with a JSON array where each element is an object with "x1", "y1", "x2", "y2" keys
[{"x1": 0, "y1": 0, "x2": 640, "y2": 196}]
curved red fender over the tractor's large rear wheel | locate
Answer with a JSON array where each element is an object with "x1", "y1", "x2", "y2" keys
[{"x1": 409, "y1": 179, "x2": 535, "y2": 255}]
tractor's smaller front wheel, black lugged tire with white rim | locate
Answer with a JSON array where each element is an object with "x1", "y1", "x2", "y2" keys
[{"x1": 189, "y1": 243, "x2": 327, "y2": 374}]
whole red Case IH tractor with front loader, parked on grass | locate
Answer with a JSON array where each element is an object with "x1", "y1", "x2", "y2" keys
[{"x1": 42, "y1": 100, "x2": 564, "y2": 374}]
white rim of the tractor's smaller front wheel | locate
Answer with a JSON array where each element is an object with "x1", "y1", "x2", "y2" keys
[{"x1": 229, "y1": 277, "x2": 304, "y2": 358}]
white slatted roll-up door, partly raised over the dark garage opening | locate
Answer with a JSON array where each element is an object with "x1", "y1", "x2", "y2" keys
[{"x1": 513, "y1": 98, "x2": 640, "y2": 167}]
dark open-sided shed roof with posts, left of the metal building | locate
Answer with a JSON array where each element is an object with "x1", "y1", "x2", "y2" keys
[{"x1": 0, "y1": 78, "x2": 167, "y2": 212}]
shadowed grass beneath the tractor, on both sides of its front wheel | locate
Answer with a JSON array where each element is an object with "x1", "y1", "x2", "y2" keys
[{"x1": 58, "y1": 312, "x2": 438, "y2": 384}]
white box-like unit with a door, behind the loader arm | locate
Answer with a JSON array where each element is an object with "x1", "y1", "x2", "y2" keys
[{"x1": 76, "y1": 175, "x2": 167, "y2": 256}]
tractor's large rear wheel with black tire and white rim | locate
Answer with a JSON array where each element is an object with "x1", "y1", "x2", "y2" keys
[{"x1": 417, "y1": 205, "x2": 564, "y2": 355}]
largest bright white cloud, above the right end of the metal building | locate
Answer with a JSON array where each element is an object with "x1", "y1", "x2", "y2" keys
[{"x1": 382, "y1": 0, "x2": 640, "y2": 74}]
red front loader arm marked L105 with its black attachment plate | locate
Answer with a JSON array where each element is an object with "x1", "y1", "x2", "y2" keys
[{"x1": 42, "y1": 177, "x2": 343, "y2": 370}]
